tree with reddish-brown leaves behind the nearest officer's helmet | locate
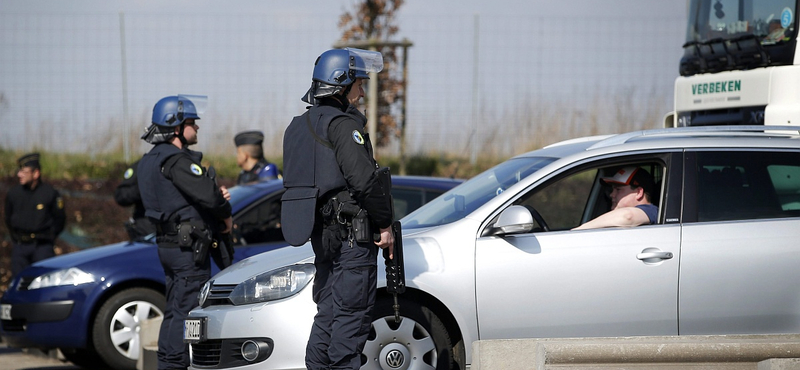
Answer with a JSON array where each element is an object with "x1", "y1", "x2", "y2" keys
[{"x1": 339, "y1": 0, "x2": 405, "y2": 146}]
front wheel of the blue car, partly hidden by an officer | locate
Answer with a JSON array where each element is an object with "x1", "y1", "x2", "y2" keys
[{"x1": 92, "y1": 288, "x2": 166, "y2": 370}]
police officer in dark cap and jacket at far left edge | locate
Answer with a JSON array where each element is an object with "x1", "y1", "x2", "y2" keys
[{"x1": 5, "y1": 153, "x2": 67, "y2": 275}]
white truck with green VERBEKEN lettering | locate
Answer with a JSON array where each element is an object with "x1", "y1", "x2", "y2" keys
[{"x1": 664, "y1": 0, "x2": 800, "y2": 127}]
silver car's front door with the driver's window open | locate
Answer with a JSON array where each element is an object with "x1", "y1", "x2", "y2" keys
[{"x1": 475, "y1": 155, "x2": 680, "y2": 339}]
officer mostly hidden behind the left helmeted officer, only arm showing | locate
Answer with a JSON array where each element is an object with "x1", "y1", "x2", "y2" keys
[{"x1": 114, "y1": 161, "x2": 156, "y2": 241}]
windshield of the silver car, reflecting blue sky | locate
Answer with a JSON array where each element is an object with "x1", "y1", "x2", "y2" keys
[{"x1": 402, "y1": 157, "x2": 556, "y2": 229}]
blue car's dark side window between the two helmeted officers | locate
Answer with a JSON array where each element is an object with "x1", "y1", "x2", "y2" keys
[{"x1": 233, "y1": 196, "x2": 284, "y2": 245}]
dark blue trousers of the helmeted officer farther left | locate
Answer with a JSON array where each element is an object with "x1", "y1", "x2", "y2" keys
[{"x1": 157, "y1": 247, "x2": 211, "y2": 370}]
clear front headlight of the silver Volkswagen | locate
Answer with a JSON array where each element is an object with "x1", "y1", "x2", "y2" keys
[{"x1": 229, "y1": 263, "x2": 317, "y2": 306}]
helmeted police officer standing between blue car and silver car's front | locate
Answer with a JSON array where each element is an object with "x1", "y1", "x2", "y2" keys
[{"x1": 139, "y1": 96, "x2": 231, "y2": 370}]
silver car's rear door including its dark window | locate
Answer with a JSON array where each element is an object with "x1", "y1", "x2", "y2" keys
[{"x1": 679, "y1": 149, "x2": 800, "y2": 335}]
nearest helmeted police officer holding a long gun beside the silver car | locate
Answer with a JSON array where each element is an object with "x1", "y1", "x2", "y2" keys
[{"x1": 281, "y1": 49, "x2": 394, "y2": 370}]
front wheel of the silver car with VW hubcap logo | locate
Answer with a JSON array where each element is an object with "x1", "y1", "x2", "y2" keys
[{"x1": 361, "y1": 298, "x2": 458, "y2": 370}]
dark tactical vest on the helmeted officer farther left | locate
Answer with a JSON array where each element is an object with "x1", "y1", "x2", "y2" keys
[{"x1": 139, "y1": 143, "x2": 201, "y2": 223}]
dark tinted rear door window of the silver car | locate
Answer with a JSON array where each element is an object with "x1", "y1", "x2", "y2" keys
[{"x1": 695, "y1": 151, "x2": 800, "y2": 221}]
